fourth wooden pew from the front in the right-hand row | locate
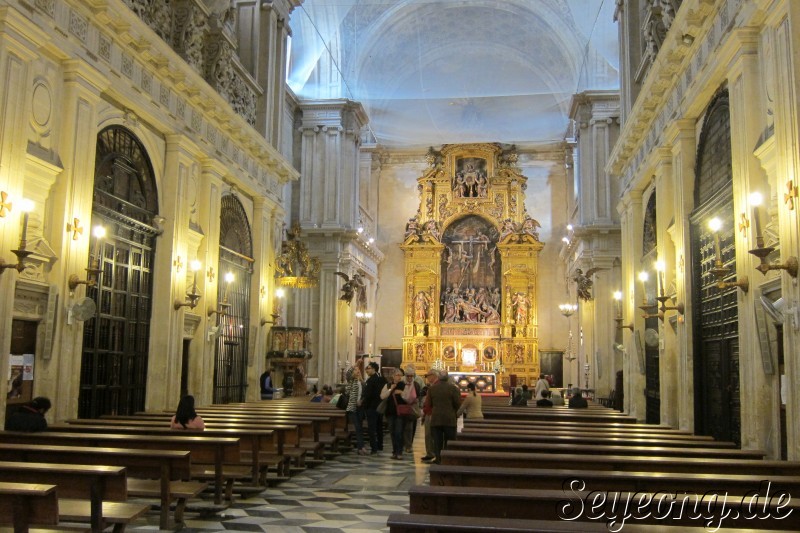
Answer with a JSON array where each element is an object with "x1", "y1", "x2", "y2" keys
[{"x1": 442, "y1": 450, "x2": 800, "y2": 479}]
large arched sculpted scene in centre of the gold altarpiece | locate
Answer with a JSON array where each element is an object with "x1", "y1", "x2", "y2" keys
[{"x1": 439, "y1": 215, "x2": 502, "y2": 324}]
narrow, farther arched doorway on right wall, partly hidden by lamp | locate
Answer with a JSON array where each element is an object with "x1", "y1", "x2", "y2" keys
[{"x1": 642, "y1": 192, "x2": 661, "y2": 424}]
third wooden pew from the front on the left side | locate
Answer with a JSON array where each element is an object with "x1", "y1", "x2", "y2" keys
[{"x1": 0, "y1": 443, "x2": 208, "y2": 529}]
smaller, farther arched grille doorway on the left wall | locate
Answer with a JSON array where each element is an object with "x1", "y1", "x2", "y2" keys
[{"x1": 214, "y1": 194, "x2": 255, "y2": 403}]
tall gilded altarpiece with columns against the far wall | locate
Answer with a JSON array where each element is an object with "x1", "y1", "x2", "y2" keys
[{"x1": 401, "y1": 144, "x2": 544, "y2": 390}]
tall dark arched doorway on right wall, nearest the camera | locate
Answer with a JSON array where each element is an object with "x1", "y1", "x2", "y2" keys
[{"x1": 691, "y1": 91, "x2": 741, "y2": 444}]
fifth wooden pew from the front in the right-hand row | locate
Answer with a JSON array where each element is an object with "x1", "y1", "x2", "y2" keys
[{"x1": 447, "y1": 439, "x2": 766, "y2": 461}]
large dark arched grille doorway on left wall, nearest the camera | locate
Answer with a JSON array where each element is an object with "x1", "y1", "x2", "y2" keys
[{"x1": 78, "y1": 126, "x2": 159, "y2": 418}]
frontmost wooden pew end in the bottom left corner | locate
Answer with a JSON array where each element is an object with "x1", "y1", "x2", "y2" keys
[{"x1": 0, "y1": 481, "x2": 58, "y2": 533}]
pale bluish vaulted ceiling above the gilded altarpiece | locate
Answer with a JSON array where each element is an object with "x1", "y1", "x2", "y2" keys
[{"x1": 288, "y1": 0, "x2": 619, "y2": 148}]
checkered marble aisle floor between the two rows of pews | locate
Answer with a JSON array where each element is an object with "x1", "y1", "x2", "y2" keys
[{"x1": 128, "y1": 427, "x2": 428, "y2": 533}]
